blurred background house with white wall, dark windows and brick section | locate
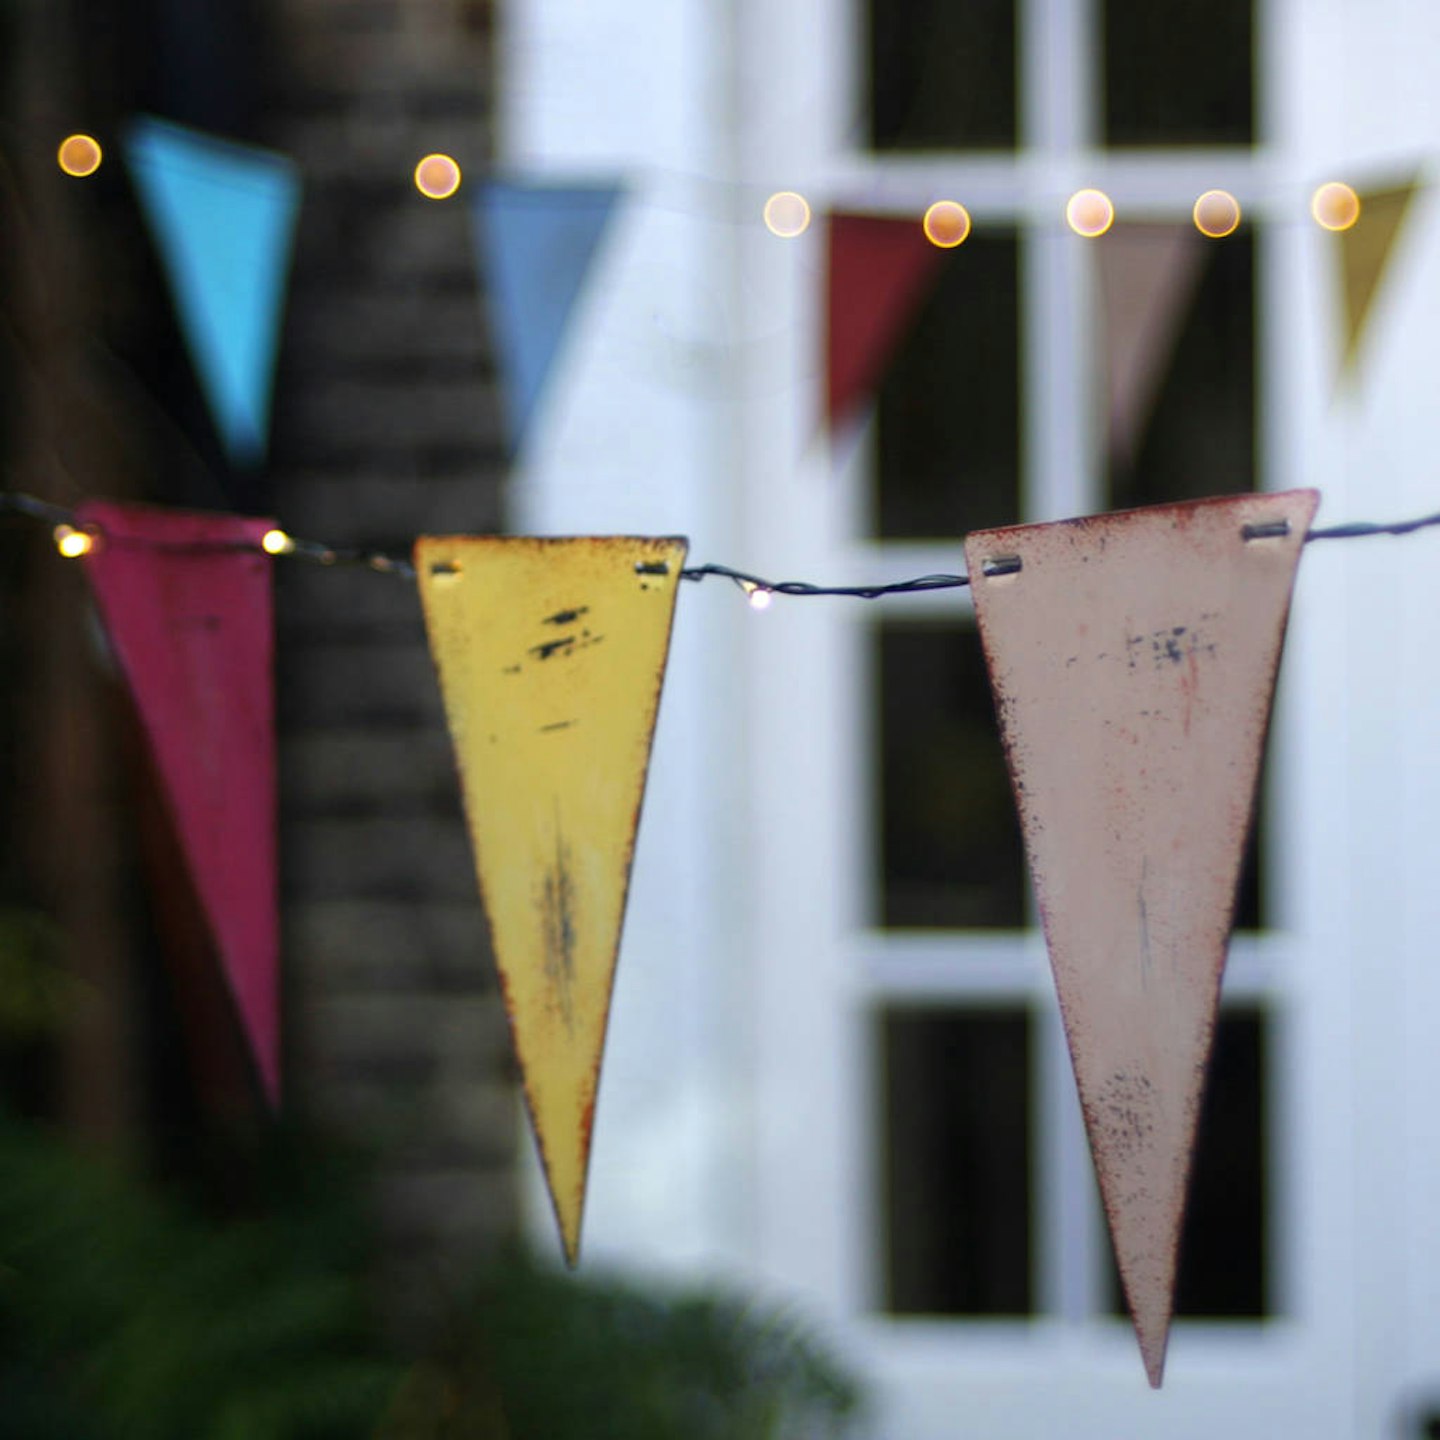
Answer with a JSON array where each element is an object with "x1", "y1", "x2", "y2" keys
[{"x1": 4, "y1": 0, "x2": 1440, "y2": 1440}]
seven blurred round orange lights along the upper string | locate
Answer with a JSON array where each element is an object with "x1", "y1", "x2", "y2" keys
[{"x1": 56, "y1": 134, "x2": 1361, "y2": 241}]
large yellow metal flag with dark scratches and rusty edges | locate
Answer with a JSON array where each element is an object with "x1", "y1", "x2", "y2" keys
[{"x1": 415, "y1": 536, "x2": 687, "y2": 1264}]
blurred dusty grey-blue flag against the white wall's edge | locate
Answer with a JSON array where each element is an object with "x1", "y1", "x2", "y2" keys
[{"x1": 474, "y1": 181, "x2": 619, "y2": 449}]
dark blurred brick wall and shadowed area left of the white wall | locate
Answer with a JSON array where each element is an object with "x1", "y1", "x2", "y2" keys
[{"x1": 4, "y1": 0, "x2": 518, "y2": 1313}]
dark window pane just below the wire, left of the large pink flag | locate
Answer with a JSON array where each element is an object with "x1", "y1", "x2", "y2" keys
[{"x1": 877, "y1": 621, "x2": 1025, "y2": 929}]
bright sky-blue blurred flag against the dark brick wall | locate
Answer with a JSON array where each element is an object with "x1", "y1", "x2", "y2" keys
[{"x1": 125, "y1": 115, "x2": 300, "y2": 465}]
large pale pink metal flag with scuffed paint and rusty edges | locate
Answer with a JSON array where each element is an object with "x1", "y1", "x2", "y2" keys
[{"x1": 965, "y1": 490, "x2": 1318, "y2": 1387}]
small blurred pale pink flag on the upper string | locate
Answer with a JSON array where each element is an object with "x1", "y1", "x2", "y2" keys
[{"x1": 1092, "y1": 225, "x2": 1210, "y2": 468}]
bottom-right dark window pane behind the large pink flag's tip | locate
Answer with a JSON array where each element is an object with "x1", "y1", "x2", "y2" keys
[{"x1": 1110, "y1": 1009, "x2": 1270, "y2": 1319}]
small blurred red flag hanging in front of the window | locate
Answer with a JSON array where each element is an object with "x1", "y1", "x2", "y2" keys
[{"x1": 825, "y1": 215, "x2": 949, "y2": 426}]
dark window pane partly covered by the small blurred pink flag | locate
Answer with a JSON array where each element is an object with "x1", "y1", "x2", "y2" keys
[{"x1": 1096, "y1": 233, "x2": 1256, "y2": 510}]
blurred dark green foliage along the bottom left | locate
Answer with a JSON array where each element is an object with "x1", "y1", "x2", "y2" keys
[{"x1": 0, "y1": 1115, "x2": 857, "y2": 1440}]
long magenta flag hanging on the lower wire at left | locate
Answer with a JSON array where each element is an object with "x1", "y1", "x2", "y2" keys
[{"x1": 79, "y1": 503, "x2": 279, "y2": 1104}]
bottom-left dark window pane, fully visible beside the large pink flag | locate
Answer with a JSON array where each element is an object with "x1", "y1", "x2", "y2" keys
[{"x1": 881, "y1": 1009, "x2": 1032, "y2": 1315}]
